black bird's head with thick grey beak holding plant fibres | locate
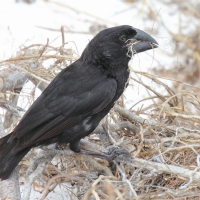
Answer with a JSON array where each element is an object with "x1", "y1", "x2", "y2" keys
[{"x1": 82, "y1": 25, "x2": 158, "y2": 67}]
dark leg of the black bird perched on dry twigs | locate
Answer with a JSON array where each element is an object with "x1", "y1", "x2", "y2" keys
[{"x1": 69, "y1": 140, "x2": 112, "y2": 164}]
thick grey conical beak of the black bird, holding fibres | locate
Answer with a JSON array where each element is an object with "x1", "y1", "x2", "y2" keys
[{"x1": 132, "y1": 28, "x2": 158, "y2": 53}]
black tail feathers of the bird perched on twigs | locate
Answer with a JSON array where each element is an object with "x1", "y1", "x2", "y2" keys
[{"x1": 0, "y1": 133, "x2": 29, "y2": 180}]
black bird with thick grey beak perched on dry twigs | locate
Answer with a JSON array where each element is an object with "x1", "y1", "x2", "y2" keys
[{"x1": 0, "y1": 25, "x2": 158, "y2": 180}]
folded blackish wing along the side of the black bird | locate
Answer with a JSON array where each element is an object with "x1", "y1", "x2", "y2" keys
[{"x1": 13, "y1": 64, "x2": 117, "y2": 151}]
